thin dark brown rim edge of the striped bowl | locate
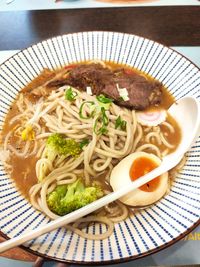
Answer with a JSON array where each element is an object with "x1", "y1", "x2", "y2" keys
[{"x1": 0, "y1": 30, "x2": 200, "y2": 266}]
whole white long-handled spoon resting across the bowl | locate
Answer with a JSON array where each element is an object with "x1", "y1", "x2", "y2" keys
[{"x1": 0, "y1": 97, "x2": 200, "y2": 253}]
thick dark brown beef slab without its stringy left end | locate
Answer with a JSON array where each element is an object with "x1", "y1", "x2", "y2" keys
[{"x1": 67, "y1": 64, "x2": 162, "y2": 110}]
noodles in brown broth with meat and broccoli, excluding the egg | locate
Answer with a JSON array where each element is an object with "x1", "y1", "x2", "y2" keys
[{"x1": 1, "y1": 62, "x2": 181, "y2": 242}]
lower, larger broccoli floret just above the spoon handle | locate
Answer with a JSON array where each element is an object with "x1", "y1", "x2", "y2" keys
[{"x1": 47, "y1": 179, "x2": 103, "y2": 216}]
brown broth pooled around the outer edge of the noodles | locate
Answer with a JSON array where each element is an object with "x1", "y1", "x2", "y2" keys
[{"x1": 0, "y1": 62, "x2": 181, "y2": 198}]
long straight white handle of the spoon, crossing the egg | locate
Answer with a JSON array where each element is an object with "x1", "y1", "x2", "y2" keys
[{"x1": 0, "y1": 156, "x2": 181, "y2": 253}]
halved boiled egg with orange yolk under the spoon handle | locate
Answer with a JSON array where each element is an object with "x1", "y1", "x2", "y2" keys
[{"x1": 110, "y1": 152, "x2": 168, "y2": 206}]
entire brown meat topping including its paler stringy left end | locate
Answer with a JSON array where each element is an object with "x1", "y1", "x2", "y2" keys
[{"x1": 23, "y1": 63, "x2": 162, "y2": 110}]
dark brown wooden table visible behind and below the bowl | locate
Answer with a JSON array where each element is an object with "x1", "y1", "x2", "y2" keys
[{"x1": 0, "y1": 6, "x2": 200, "y2": 266}]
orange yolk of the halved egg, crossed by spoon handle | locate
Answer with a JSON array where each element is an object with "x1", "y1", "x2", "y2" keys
[{"x1": 129, "y1": 157, "x2": 160, "y2": 192}]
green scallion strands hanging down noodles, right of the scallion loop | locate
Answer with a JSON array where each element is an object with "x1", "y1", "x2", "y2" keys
[{"x1": 94, "y1": 107, "x2": 109, "y2": 135}]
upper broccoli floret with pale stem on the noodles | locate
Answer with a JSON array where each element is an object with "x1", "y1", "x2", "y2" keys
[{"x1": 38, "y1": 133, "x2": 81, "y2": 182}]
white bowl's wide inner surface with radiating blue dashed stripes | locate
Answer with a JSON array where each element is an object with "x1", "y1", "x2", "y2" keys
[{"x1": 0, "y1": 32, "x2": 200, "y2": 264}]
